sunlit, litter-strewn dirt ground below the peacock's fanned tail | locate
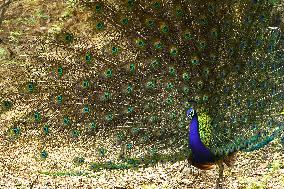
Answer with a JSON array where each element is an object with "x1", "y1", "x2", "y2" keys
[{"x1": 0, "y1": 134, "x2": 284, "y2": 189}]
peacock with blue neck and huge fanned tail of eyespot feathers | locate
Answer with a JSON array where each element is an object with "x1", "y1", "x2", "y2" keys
[{"x1": 1, "y1": 0, "x2": 284, "y2": 187}]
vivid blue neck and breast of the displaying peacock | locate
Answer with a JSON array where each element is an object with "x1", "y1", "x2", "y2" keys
[{"x1": 188, "y1": 113, "x2": 214, "y2": 163}]
